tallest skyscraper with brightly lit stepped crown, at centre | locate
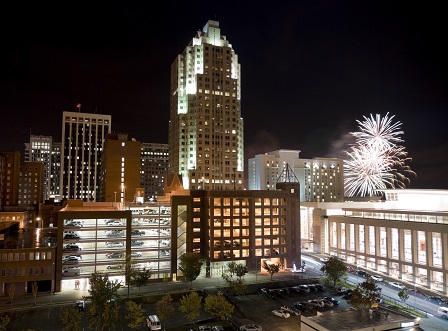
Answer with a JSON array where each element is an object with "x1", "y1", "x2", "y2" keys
[{"x1": 168, "y1": 21, "x2": 244, "y2": 190}]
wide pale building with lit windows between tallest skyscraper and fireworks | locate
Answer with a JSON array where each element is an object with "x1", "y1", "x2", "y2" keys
[{"x1": 248, "y1": 149, "x2": 344, "y2": 202}]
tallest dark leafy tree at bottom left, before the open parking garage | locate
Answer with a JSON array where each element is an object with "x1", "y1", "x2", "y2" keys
[{"x1": 85, "y1": 273, "x2": 121, "y2": 330}]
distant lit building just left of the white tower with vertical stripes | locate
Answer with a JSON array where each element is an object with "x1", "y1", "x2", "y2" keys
[{"x1": 25, "y1": 135, "x2": 53, "y2": 200}]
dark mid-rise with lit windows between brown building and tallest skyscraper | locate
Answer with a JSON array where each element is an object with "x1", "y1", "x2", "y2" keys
[{"x1": 140, "y1": 143, "x2": 169, "y2": 201}]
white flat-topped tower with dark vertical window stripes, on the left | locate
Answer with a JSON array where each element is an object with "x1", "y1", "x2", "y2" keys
[{"x1": 59, "y1": 112, "x2": 112, "y2": 201}]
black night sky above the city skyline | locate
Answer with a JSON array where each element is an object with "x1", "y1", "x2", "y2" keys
[{"x1": 0, "y1": 1, "x2": 448, "y2": 189}]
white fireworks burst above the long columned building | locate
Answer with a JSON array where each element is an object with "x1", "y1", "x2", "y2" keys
[{"x1": 344, "y1": 113, "x2": 415, "y2": 196}]
